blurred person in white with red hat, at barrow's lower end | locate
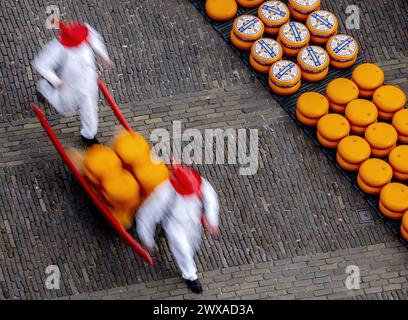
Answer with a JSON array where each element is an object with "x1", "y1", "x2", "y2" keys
[{"x1": 136, "y1": 165, "x2": 219, "y2": 293}]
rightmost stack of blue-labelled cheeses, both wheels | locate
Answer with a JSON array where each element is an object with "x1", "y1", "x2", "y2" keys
[{"x1": 326, "y1": 34, "x2": 359, "y2": 69}]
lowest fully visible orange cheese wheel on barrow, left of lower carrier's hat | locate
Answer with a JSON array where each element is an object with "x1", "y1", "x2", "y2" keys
[{"x1": 101, "y1": 170, "x2": 140, "y2": 210}]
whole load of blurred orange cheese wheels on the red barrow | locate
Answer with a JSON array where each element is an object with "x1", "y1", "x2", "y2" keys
[{"x1": 83, "y1": 132, "x2": 169, "y2": 229}]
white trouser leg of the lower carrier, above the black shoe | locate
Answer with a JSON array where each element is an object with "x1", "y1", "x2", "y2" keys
[{"x1": 166, "y1": 232, "x2": 197, "y2": 281}]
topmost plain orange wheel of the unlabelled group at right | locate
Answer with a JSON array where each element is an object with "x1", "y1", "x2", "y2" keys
[{"x1": 352, "y1": 63, "x2": 384, "y2": 91}]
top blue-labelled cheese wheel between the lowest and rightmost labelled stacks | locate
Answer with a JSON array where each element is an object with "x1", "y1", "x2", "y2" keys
[{"x1": 297, "y1": 46, "x2": 330, "y2": 73}]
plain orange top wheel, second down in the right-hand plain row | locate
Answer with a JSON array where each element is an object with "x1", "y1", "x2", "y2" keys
[{"x1": 373, "y1": 85, "x2": 407, "y2": 113}]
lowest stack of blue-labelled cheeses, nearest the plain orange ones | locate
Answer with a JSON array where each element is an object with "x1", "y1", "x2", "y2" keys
[{"x1": 269, "y1": 60, "x2": 301, "y2": 95}]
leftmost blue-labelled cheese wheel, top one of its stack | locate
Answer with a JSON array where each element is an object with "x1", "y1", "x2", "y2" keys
[{"x1": 232, "y1": 14, "x2": 264, "y2": 41}]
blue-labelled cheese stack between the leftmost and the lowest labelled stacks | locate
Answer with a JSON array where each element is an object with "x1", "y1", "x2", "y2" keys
[{"x1": 249, "y1": 38, "x2": 283, "y2": 73}]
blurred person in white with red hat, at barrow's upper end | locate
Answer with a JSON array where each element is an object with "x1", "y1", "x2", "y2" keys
[{"x1": 33, "y1": 22, "x2": 113, "y2": 145}]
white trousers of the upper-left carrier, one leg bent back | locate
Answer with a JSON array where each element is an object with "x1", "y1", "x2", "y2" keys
[{"x1": 37, "y1": 79, "x2": 98, "y2": 139}]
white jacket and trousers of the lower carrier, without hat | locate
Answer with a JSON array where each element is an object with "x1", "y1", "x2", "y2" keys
[{"x1": 136, "y1": 179, "x2": 219, "y2": 280}]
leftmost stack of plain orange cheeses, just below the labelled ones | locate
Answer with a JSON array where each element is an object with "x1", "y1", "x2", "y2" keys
[{"x1": 296, "y1": 92, "x2": 329, "y2": 126}]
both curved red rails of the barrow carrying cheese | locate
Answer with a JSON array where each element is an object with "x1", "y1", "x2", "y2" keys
[{"x1": 31, "y1": 80, "x2": 153, "y2": 266}]
